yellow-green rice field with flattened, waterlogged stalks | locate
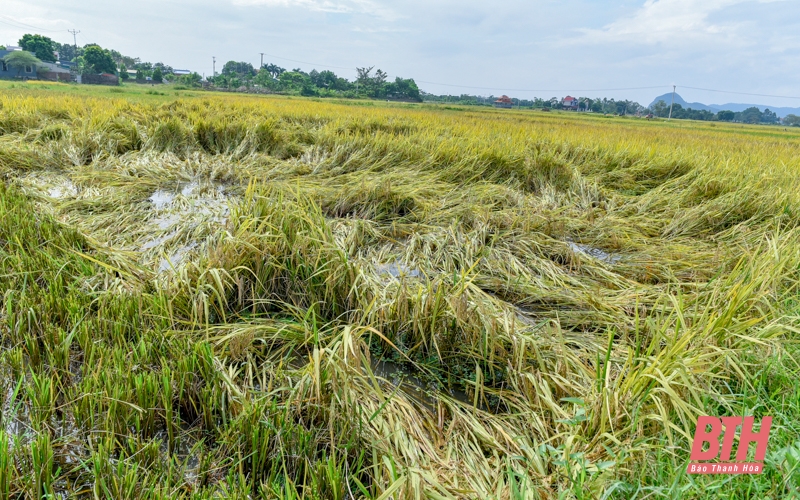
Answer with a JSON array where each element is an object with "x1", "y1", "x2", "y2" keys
[{"x1": 0, "y1": 80, "x2": 800, "y2": 499}]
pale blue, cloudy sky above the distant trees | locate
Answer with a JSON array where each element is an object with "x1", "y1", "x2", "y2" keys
[{"x1": 0, "y1": 0, "x2": 800, "y2": 106}]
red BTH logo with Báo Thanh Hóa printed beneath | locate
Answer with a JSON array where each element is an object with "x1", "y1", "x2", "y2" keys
[{"x1": 686, "y1": 417, "x2": 772, "y2": 474}]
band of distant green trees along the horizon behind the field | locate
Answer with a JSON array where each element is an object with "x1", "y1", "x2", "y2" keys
[{"x1": 12, "y1": 33, "x2": 800, "y2": 118}]
